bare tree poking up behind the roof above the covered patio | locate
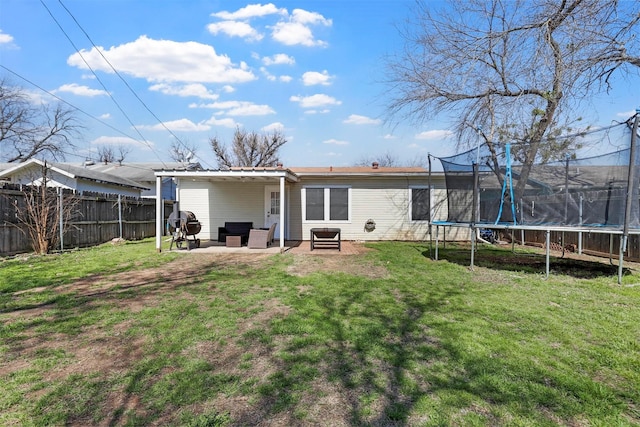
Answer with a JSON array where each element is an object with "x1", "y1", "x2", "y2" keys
[{"x1": 210, "y1": 128, "x2": 287, "y2": 168}]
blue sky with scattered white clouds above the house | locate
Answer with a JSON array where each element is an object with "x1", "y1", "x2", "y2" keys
[{"x1": 0, "y1": 0, "x2": 640, "y2": 168}]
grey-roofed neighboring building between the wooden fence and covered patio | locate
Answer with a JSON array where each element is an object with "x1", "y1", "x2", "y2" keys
[{"x1": 86, "y1": 162, "x2": 202, "y2": 200}]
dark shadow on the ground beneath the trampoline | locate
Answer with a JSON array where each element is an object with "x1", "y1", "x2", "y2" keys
[{"x1": 423, "y1": 246, "x2": 631, "y2": 279}]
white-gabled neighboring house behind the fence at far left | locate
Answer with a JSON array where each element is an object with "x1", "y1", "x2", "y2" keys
[{"x1": 0, "y1": 159, "x2": 148, "y2": 197}]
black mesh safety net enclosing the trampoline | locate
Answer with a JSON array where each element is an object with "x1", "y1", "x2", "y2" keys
[{"x1": 439, "y1": 120, "x2": 640, "y2": 229}]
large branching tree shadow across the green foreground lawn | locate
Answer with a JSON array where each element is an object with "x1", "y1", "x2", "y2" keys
[{"x1": 225, "y1": 254, "x2": 624, "y2": 426}]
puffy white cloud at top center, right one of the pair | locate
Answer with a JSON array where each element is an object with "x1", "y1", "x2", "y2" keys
[{"x1": 271, "y1": 9, "x2": 333, "y2": 47}]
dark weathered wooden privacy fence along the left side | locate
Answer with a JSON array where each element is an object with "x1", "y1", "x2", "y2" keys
[{"x1": 0, "y1": 184, "x2": 173, "y2": 255}]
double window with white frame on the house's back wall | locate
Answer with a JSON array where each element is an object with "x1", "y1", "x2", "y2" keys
[{"x1": 303, "y1": 187, "x2": 351, "y2": 221}]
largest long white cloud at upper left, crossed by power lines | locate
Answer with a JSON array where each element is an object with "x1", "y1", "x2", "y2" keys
[{"x1": 67, "y1": 35, "x2": 256, "y2": 83}]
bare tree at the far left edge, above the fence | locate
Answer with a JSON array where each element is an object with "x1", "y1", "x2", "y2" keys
[{"x1": 0, "y1": 79, "x2": 81, "y2": 163}]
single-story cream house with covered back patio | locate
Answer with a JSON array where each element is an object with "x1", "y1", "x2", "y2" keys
[{"x1": 156, "y1": 163, "x2": 462, "y2": 250}]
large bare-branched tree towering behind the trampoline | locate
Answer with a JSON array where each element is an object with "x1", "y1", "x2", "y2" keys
[{"x1": 388, "y1": 0, "x2": 640, "y2": 198}]
